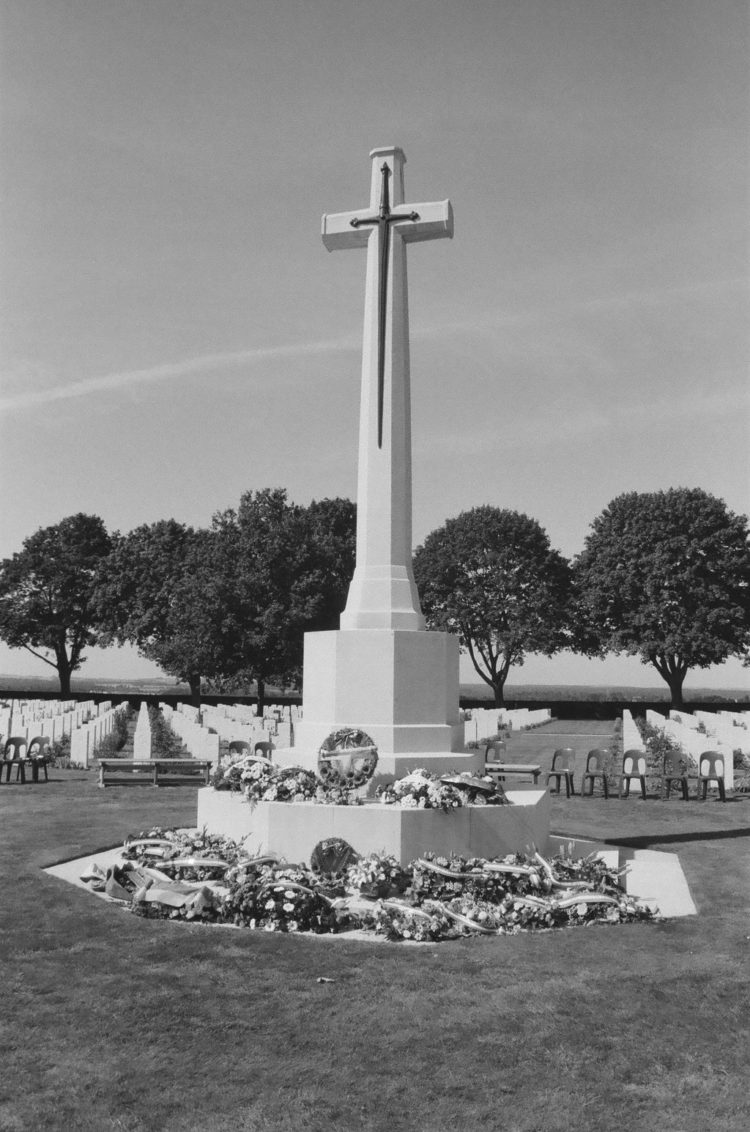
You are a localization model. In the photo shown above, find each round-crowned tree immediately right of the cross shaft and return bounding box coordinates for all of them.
[414,506,570,708]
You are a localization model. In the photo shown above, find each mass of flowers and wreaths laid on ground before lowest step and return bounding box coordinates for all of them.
[83,829,655,942]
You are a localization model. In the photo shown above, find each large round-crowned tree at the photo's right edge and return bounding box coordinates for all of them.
[574,488,750,709]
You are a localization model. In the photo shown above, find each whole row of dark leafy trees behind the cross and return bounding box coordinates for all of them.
[0,488,750,706]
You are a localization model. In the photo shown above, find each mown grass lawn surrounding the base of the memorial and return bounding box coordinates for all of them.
[0,770,750,1132]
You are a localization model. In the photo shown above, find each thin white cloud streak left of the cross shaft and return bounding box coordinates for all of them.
[0,336,361,421]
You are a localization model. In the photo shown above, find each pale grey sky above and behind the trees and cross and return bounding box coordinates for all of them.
[0,0,750,686]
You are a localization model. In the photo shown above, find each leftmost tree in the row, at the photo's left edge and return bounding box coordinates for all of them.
[0,513,111,696]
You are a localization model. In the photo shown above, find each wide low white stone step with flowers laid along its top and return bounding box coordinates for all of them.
[197,787,550,865]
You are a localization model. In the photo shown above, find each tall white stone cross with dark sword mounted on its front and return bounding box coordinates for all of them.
[322,146,454,629]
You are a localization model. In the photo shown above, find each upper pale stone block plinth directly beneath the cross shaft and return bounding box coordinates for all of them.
[294,629,463,766]
